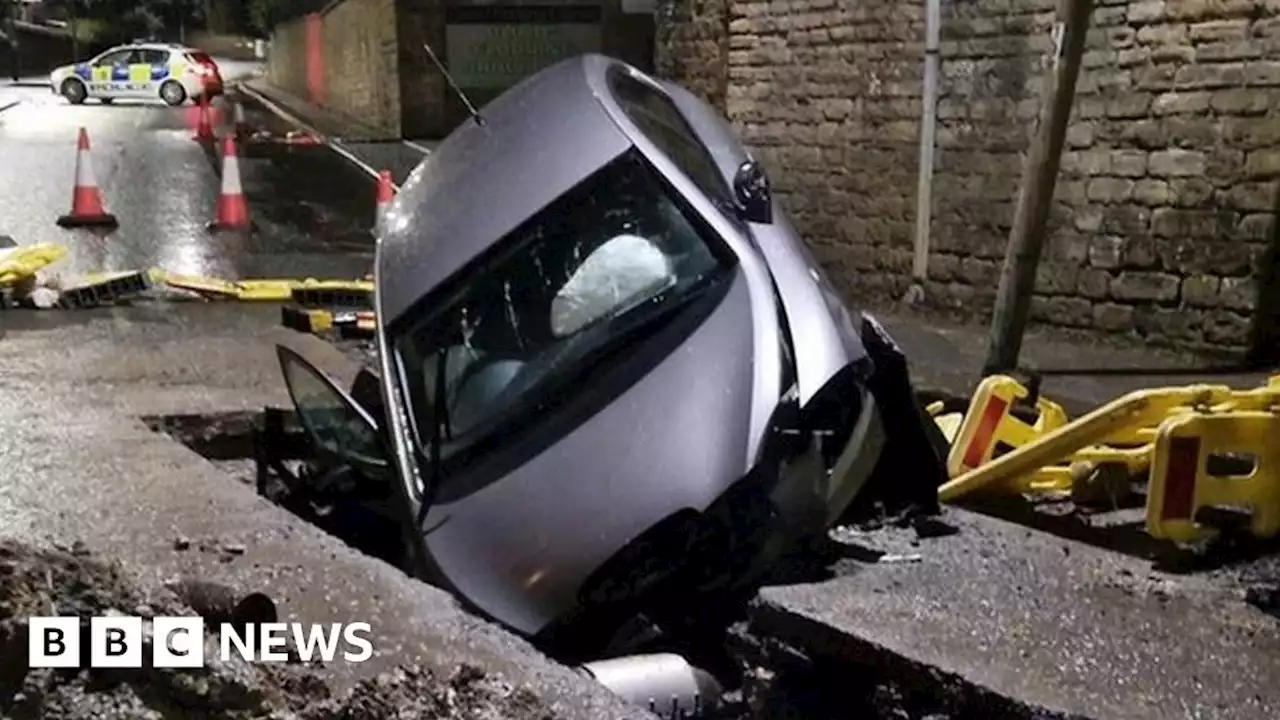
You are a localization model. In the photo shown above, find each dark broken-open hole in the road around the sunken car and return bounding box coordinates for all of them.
[142,410,1054,720]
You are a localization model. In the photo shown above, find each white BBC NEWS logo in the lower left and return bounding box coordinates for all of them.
[27,615,374,667]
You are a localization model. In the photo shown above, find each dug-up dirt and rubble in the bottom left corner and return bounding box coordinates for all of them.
[0,541,557,720]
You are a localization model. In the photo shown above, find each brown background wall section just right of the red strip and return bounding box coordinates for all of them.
[323,0,401,137]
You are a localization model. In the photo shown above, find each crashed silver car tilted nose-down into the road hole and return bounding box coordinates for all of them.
[282,55,933,657]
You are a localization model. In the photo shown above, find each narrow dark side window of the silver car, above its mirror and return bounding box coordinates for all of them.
[609,68,735,218]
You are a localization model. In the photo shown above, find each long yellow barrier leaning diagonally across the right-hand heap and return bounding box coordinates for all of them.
[938,383,1256,502]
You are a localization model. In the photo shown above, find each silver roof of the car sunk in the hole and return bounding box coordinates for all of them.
[378,54,632,320]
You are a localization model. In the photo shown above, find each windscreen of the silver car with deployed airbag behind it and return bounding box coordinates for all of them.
[392,150,735,468]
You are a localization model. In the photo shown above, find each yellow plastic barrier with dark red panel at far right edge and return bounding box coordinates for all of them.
[1147,407,1280,542]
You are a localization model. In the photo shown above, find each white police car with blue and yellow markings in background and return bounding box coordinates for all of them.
[49,42,215,105]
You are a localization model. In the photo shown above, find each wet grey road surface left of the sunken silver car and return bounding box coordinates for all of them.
[0,60,649,720]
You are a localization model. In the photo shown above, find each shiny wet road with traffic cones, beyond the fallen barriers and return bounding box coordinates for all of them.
[0,61,374,278]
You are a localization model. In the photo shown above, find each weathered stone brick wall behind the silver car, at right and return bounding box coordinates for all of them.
[658,0,1280,345]
